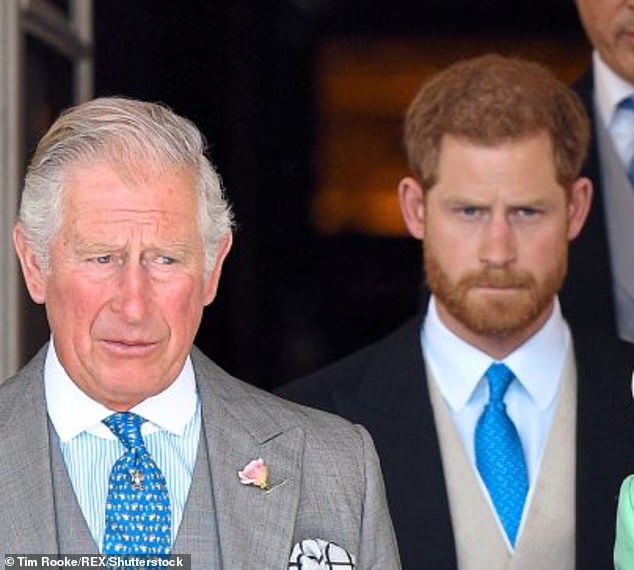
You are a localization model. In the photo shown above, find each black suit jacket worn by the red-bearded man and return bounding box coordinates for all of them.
[280,317,634,570]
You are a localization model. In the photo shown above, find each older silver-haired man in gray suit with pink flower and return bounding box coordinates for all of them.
[0,98,400,570]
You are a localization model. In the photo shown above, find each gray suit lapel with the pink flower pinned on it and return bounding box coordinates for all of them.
[193,352,304,569]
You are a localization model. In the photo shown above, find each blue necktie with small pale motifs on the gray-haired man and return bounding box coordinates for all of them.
[103,412,172,555]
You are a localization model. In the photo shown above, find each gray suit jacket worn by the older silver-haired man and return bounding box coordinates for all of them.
[0,349,400,570]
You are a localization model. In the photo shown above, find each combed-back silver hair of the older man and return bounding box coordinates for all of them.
[18,97,233,274]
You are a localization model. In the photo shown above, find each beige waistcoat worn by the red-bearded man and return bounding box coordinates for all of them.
[427,350,577,570]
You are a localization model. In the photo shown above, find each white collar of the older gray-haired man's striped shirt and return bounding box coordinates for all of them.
[44,338,198,442]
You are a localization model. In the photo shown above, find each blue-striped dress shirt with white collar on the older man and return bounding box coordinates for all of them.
[44,341,201,550]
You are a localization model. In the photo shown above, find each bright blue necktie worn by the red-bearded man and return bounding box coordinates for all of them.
[475,364,528,546]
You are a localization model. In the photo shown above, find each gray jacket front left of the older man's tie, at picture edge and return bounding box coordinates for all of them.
[0,347,58,554]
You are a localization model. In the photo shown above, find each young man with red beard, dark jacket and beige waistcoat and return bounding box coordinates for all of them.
[282,55,634,570]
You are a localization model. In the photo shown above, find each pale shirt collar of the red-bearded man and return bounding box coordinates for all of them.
[421,296,571,411]
